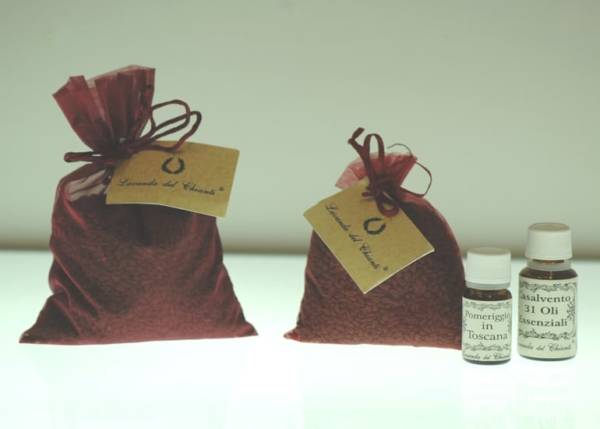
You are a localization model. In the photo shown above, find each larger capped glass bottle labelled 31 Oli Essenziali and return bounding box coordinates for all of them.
[518,223,577,360]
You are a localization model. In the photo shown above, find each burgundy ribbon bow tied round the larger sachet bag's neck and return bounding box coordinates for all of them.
[65,100,202,167]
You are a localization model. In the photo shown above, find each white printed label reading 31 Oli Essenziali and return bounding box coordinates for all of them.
[519,277,577,359]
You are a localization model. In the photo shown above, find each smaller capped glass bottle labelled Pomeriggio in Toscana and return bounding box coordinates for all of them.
[462,247,512,364]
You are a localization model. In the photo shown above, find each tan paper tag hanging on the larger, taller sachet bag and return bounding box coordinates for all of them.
[106,142,239,217]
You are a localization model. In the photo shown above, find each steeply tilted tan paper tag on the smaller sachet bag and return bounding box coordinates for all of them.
[304,179,434,293]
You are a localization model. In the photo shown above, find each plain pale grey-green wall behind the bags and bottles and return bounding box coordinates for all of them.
[0,0,600,257]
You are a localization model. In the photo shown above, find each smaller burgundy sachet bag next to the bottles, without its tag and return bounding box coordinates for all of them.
[285,128,465,349]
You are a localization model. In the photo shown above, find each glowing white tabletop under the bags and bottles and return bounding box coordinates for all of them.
[0,252,600,429]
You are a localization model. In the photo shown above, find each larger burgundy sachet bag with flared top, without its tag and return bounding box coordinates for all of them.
[21,66,256,344]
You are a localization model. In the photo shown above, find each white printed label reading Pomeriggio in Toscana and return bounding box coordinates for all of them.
[462,298,512,362]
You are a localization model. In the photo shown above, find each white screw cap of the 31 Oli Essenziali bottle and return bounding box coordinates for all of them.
[525,223,573,261]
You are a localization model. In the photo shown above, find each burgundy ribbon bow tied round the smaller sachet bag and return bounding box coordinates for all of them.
[348,127,433,217]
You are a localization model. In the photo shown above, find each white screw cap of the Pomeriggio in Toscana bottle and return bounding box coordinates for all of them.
[466,247,510,289]
